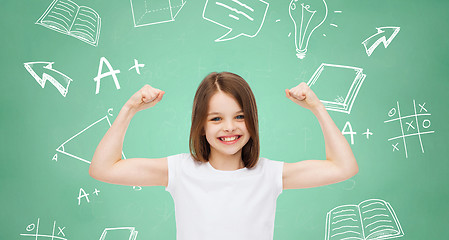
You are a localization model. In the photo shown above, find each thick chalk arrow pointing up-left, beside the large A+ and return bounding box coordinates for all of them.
[23,62,72,97]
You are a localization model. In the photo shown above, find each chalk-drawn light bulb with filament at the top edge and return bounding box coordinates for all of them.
[288,0,328,59]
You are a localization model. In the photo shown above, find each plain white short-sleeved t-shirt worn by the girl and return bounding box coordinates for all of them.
[166,153,284,240]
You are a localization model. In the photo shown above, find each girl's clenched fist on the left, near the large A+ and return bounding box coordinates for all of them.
[126,84,165,112]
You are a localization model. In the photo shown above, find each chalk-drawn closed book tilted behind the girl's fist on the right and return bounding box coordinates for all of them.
[307,63,366,114]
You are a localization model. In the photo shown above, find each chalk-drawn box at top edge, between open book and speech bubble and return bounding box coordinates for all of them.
[131,0,186,27]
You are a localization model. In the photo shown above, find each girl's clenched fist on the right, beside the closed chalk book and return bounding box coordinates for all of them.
[285,82,323,110]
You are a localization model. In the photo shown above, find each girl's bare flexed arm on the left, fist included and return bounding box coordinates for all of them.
[89,85,168,186]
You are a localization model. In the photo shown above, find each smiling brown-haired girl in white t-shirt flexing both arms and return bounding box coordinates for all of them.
[89,72,358,240]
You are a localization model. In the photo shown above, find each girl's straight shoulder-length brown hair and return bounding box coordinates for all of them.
[189,72,260,168]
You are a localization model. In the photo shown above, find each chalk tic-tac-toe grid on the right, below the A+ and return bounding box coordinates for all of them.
[384,100,435,158]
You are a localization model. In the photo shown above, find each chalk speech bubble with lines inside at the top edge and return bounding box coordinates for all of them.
[203,0,269,42]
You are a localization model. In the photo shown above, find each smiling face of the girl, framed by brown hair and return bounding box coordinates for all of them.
[204,91,250,157]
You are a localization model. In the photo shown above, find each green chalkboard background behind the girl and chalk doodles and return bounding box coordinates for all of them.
[0,0,449,240]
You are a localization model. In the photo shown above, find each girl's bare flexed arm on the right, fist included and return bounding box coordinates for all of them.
[283,83,358,189]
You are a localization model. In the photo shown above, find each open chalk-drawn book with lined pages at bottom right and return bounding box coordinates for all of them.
[325,199,404,240]
